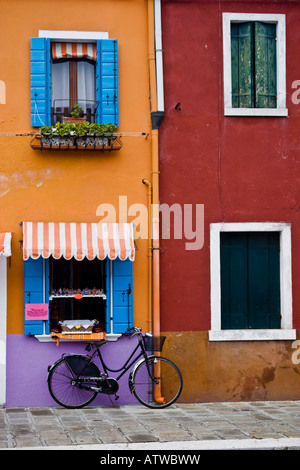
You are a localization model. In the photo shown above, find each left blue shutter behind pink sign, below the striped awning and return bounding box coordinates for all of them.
[24,258,50,335]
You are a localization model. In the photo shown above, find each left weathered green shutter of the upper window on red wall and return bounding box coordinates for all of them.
[231,22,254,108]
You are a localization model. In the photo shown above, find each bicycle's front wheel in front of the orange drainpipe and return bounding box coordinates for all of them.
[130,356,183,408]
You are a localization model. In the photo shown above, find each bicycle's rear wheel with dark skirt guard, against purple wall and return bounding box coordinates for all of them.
[48,354,100,408]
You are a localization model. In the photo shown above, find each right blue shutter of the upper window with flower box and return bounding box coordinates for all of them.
[96,39,119,126]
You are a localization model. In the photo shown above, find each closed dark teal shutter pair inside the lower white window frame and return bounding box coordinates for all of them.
[220,232,280,329]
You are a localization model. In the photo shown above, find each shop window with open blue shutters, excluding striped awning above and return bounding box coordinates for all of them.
[24,257,133,335]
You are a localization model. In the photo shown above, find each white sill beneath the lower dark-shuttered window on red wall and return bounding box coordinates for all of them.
[208,329,296,341]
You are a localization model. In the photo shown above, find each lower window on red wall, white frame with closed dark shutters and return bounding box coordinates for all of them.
[209,223,295,341]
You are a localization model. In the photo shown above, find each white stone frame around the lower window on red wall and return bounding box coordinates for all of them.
[209,222,296,341]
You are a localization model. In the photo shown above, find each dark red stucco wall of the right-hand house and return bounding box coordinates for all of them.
[160,0,300,331]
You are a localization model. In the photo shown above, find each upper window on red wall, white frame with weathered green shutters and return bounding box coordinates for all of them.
[223,13,287,116]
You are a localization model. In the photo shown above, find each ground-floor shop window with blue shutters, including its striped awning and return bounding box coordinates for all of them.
[23,222,135,336]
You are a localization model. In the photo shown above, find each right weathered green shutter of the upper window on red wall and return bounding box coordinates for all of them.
[254,22,277,108]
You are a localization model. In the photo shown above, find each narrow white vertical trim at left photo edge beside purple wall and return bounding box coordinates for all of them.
[0,256,7,406]
